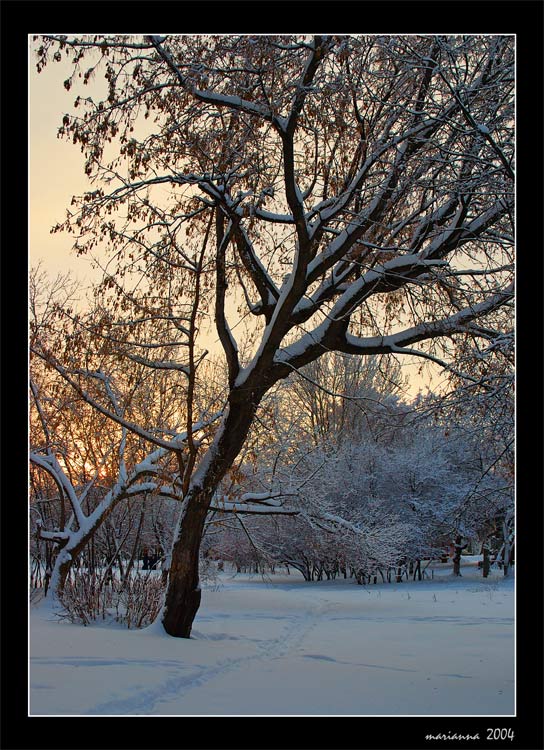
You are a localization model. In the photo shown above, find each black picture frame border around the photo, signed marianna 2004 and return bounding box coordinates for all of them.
[0,0,544,750]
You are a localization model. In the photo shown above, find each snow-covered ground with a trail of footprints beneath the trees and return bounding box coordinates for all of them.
[29,567,515,716]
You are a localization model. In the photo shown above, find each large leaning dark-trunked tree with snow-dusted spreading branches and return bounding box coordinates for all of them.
[36,36,514,637]
